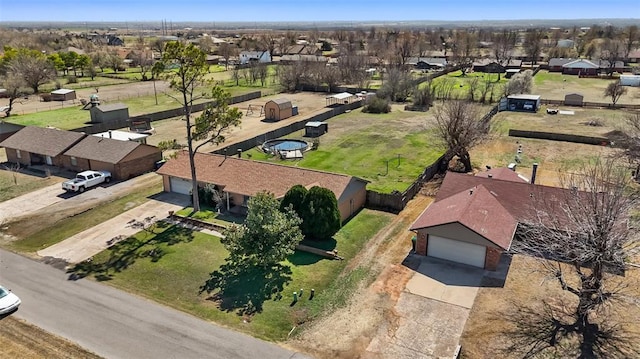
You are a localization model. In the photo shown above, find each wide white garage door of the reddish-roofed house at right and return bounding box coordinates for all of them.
[427,235,487,268]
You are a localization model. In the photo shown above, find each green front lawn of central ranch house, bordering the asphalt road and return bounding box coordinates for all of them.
[67,209,393,341]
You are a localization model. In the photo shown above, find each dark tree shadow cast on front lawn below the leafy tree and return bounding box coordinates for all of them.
[199,262,292,316]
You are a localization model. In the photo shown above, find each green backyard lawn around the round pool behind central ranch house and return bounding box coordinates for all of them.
[246,109,443,193]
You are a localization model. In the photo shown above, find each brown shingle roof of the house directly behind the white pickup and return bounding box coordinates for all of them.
[64,136,151,163]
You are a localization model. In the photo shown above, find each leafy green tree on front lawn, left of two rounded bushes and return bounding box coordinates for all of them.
[221,192,303,268]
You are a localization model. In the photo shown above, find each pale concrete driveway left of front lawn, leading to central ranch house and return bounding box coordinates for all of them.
[38,193,190,263]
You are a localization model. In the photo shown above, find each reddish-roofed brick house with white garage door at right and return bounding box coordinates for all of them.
[410,169,570,270]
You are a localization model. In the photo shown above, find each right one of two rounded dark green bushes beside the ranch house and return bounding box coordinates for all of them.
[302,186,341,239]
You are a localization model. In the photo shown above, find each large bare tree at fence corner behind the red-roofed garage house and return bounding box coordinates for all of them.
[434,100,488,172]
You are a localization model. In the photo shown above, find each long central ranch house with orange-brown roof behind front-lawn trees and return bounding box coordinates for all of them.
[157,152,367,222]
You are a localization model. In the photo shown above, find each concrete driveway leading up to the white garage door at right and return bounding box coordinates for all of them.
[363,254,485,359]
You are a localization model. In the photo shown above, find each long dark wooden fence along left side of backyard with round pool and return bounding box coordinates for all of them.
[213,101,363,155]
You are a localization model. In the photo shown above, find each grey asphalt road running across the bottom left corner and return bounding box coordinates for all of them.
[0,250,308,359]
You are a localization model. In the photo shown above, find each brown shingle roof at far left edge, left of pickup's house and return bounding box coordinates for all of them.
[0,126,86,157]
